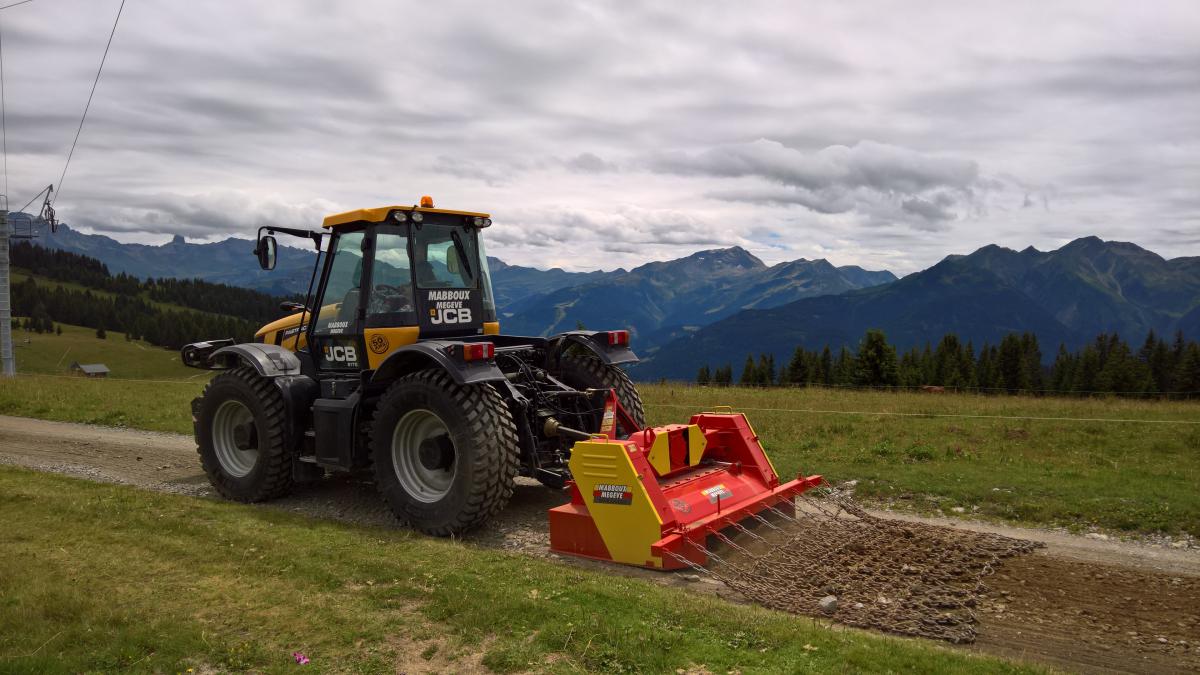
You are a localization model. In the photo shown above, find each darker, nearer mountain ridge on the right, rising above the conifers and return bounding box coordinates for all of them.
[636,237,1200,378]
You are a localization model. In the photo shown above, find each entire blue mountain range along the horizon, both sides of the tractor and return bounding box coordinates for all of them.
[23,219,1200,378]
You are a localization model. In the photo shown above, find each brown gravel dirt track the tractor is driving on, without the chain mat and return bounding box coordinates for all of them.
[0,416,1200,673]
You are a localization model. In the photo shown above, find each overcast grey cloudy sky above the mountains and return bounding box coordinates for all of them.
[0,0,1200,274]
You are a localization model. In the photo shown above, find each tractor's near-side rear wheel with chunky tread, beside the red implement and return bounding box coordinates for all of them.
[371,370,520,537]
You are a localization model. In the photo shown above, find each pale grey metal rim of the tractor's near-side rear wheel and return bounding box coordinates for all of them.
[391,410,458,503]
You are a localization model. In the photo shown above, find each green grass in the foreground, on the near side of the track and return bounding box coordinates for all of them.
[0,467,1032,674]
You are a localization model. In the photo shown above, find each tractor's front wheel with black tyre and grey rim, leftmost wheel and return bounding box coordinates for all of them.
[197,366,292,502]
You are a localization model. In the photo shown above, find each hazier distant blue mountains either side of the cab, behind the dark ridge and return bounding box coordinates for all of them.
[25,225,895,351]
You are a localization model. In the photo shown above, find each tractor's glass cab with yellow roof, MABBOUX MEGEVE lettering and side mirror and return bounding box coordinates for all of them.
[257,197,499,371]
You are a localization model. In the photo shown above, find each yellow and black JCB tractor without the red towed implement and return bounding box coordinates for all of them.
[181,197,643,536]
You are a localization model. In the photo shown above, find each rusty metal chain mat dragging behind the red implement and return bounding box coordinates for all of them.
[670,488,1042,644]
